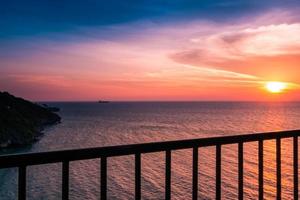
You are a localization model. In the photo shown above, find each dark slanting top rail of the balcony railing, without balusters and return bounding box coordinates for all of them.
[0,130,300,168]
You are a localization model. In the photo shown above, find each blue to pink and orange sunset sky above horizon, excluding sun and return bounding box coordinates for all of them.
[0,0,300,101]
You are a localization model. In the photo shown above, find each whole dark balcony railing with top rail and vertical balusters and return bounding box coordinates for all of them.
[0,130,300,200]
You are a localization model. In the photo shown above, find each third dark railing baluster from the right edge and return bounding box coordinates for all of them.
[258,140,264,200]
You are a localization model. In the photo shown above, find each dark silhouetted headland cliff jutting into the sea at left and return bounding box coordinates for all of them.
[0,92,61,148]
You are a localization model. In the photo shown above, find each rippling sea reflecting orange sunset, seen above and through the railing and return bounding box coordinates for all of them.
[0,102,300,200]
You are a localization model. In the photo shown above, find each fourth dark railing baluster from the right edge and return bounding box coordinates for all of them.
[238,142,244,200]
